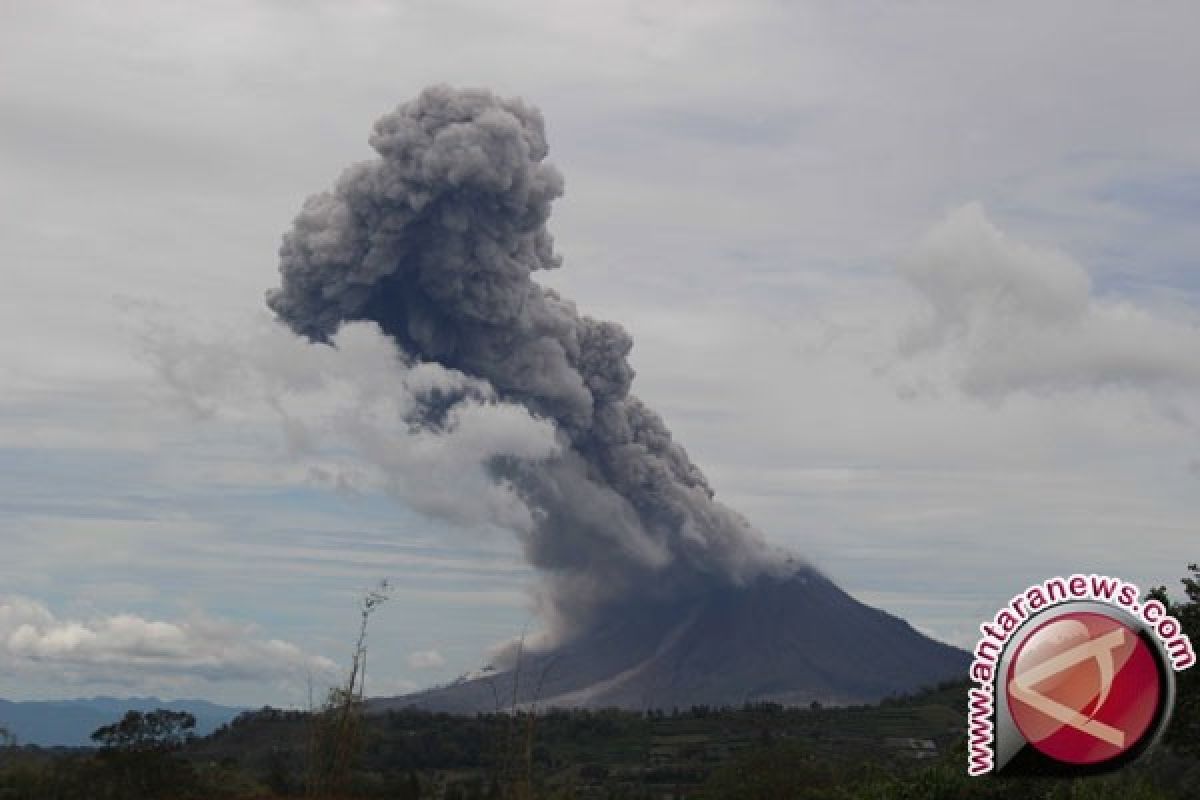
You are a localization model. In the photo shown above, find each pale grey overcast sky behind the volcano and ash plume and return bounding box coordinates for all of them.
[0,0,1200,705]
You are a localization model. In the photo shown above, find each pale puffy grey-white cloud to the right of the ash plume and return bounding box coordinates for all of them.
[901,204,1200,397]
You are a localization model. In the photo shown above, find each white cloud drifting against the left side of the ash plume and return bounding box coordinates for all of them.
[144,318,558,531]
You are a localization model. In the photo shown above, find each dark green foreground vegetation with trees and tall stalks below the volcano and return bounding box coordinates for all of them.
[0,565,1200,800]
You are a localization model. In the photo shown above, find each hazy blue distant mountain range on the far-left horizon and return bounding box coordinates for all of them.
[0,697,245,747]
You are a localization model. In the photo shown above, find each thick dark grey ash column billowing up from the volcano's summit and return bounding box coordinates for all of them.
[268,86,780,633]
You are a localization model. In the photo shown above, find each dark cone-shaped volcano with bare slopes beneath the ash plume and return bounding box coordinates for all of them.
[379,569,970,714]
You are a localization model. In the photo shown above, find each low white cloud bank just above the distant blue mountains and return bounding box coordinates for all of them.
[0,596,335,682]
